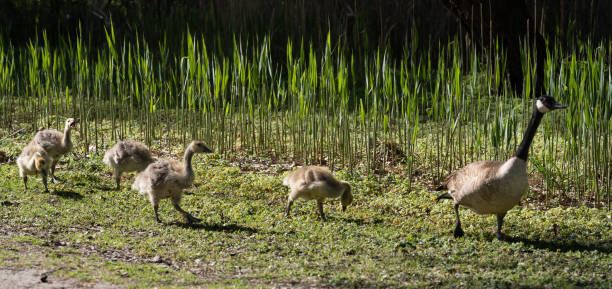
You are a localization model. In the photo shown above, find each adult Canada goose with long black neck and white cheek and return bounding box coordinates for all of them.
[436,95,565,239]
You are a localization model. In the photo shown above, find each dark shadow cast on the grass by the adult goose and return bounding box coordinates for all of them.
[504,236,612,254]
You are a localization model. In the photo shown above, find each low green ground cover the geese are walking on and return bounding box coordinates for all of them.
[0,127,612,288]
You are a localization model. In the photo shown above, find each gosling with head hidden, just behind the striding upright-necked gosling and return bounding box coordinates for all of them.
[102,141,154,190]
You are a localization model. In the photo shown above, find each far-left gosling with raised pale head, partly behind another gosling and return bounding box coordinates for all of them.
[33,118,79,182]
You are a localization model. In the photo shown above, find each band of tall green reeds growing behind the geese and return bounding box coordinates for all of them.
[0,27,612,208]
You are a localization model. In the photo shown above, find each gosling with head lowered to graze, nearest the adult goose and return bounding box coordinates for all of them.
[283,166,353,220]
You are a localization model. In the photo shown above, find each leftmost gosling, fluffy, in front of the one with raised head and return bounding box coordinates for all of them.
[17,142,51,193]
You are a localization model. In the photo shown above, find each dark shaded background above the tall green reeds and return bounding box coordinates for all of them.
[0,0,612,95]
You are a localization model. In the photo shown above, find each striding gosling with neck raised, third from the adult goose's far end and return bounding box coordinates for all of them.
[132,140,212,224]
